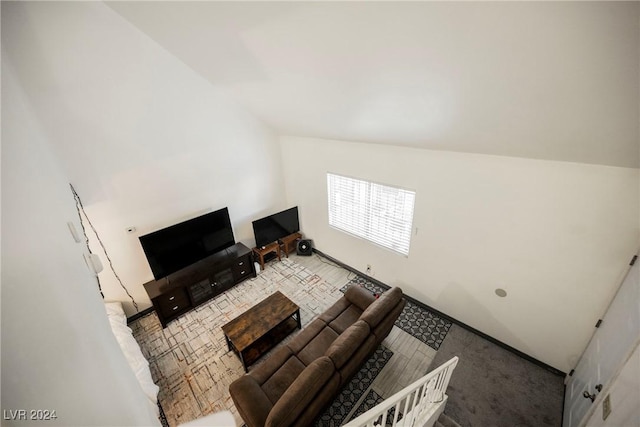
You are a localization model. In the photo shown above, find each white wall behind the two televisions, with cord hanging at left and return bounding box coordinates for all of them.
[3,2,286,314]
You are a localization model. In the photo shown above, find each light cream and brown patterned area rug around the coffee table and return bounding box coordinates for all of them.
[129,259,350,427]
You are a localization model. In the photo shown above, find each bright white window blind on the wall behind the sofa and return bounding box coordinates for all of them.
[327,173,416,255]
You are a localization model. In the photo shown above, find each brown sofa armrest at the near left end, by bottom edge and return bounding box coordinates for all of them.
[229,375,273,427]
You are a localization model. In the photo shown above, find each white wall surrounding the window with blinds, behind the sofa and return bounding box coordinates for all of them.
[281,137,640,372]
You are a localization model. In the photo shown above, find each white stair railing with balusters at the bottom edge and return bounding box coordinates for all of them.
[343,357,458,427]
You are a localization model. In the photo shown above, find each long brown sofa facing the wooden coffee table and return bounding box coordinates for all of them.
[229,286,406,427]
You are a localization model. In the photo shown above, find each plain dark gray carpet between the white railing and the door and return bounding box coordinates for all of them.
[430,325,564,427]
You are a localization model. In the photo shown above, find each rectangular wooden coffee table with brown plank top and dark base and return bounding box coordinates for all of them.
[222,291,302,372]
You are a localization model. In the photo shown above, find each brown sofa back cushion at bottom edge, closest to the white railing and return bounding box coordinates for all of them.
[265,356,335,427]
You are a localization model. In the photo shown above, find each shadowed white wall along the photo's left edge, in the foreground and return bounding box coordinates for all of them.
[1,41,158,426]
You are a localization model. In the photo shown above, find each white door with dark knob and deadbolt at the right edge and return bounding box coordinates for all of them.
[562,261,640,427]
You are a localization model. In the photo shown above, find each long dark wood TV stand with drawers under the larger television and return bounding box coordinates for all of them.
[144,243,256,328]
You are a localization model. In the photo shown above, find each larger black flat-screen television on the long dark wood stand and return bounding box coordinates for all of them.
[140,208,235,280]
